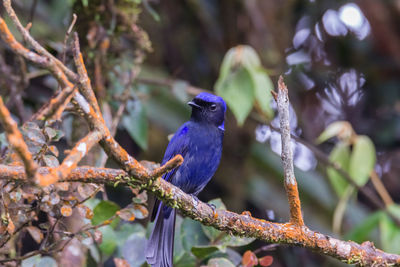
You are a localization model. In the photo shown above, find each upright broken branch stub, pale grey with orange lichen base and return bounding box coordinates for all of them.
[275,76,304,226]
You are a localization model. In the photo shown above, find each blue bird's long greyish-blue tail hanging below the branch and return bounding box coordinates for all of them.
[146,203,176,267]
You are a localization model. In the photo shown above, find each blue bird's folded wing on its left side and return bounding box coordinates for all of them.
[151,123,189,221]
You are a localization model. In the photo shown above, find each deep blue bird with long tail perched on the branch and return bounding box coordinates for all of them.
[146,93,226,267]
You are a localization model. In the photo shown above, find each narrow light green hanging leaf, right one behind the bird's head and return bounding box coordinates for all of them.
[250,68,274,118]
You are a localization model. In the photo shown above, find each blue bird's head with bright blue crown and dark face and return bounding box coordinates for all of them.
[188,93,226,131]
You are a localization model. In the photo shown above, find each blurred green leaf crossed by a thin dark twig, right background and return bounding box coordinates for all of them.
[327,142,350,197]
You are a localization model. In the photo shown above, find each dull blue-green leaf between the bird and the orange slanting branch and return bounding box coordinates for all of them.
[122,101,149,150]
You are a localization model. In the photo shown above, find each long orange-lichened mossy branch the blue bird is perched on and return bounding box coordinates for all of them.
[0,165,400,266]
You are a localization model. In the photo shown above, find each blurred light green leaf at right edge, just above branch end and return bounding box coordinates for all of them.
[379,214,400,254]
